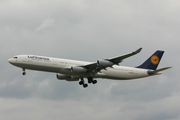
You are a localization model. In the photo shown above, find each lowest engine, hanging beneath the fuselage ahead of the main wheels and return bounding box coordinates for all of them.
[56,73,79,81]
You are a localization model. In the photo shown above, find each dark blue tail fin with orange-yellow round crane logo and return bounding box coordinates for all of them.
[137,50,164,70]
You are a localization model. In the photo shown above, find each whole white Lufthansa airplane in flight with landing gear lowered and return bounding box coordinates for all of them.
[8,48,171,88]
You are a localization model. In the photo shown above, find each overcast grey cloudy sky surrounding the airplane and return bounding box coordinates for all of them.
[0,0,180,120]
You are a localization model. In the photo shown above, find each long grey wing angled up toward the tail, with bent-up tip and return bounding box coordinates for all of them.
[81,48,142,75]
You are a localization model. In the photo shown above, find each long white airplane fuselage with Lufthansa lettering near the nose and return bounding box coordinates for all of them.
[8,55,152,80]
